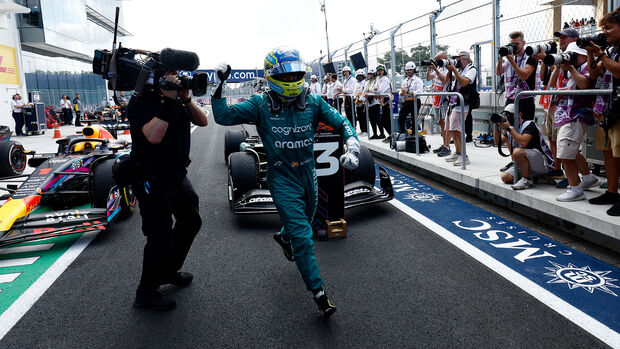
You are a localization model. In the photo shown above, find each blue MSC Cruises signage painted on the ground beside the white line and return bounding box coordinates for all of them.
[387,169,620,333]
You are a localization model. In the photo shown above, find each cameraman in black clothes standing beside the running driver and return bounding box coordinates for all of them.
[128,71,208,310]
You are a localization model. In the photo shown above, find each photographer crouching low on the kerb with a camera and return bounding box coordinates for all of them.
[498,103,552,190]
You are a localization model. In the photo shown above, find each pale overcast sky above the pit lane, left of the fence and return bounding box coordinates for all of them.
[121,0,454,69]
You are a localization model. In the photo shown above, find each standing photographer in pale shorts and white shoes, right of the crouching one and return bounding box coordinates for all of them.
[549,42,599,201]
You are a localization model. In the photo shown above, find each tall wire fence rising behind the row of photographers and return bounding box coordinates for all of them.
[311,0,608,89]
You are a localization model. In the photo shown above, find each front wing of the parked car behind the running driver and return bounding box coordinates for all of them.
[232,166,394,214]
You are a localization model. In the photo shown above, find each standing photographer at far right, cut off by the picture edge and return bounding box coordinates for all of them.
[586,9,620,216]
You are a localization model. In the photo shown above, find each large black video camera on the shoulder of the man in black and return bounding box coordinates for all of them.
[93,45,208,96]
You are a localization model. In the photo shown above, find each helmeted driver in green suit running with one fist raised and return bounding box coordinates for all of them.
[211,47,360,318]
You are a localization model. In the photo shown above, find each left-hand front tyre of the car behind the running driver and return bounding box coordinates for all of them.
[228,152,259,204]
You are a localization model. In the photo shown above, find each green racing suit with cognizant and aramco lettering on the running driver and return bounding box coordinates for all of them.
[211,93,357,290]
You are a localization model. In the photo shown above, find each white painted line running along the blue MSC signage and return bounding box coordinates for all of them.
[388,199,620,348]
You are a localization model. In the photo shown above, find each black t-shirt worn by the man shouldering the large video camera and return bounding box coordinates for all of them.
[127,93,191,177]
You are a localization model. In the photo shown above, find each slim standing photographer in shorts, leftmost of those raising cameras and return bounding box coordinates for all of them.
[426,51,451,157]
